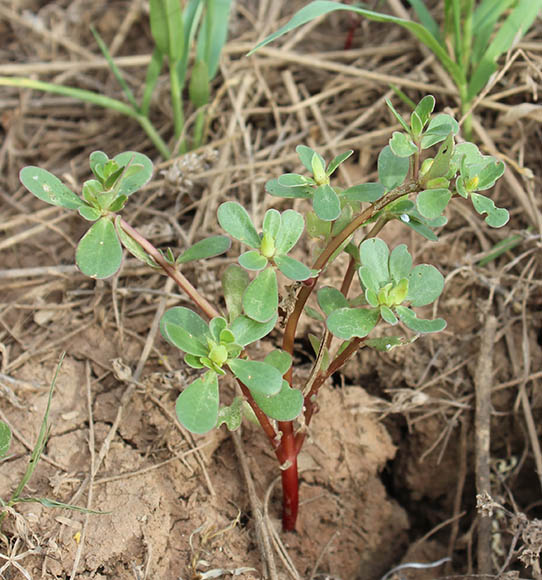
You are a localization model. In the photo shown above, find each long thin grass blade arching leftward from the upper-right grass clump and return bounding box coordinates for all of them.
[248,0,466,86]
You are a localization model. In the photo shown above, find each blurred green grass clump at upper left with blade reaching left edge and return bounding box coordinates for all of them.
[0,0,231,159]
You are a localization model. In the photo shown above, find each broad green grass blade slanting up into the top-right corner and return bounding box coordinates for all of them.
[468,0,542,100]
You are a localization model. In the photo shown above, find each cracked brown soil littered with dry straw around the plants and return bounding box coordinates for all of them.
[0,0,542,580]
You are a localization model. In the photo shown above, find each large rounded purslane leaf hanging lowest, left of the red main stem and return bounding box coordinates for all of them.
[175,372,219,434]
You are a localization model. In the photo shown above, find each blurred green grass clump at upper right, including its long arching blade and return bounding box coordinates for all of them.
[251,0,542,139]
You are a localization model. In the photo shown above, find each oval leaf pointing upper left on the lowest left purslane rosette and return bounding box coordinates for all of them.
[160,306,211,356]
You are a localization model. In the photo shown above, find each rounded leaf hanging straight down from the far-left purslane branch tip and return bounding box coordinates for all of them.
[75,218,122,279]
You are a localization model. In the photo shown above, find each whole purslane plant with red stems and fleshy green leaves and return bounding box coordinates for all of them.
[21,96,508,530]
